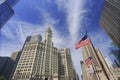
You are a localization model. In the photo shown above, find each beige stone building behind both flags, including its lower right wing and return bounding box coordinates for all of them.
[80,43,120,80]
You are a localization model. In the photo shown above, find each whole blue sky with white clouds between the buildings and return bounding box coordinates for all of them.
[0,0,114,79]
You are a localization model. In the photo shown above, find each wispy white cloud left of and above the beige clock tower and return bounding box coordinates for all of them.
[0,11,60,56]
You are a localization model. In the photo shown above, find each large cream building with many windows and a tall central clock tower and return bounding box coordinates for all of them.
[12,28,76,80]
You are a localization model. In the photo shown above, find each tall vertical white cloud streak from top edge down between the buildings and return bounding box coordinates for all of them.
[56,0,86,75]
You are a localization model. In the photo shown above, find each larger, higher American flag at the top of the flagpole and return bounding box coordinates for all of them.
[75,34,90,49]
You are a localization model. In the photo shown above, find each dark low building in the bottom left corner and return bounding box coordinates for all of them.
[0,57,15,80]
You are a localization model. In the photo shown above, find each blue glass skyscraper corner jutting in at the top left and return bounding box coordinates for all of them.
[0,0,19,29]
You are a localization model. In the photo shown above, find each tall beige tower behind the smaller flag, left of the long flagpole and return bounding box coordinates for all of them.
[82,43,107,80]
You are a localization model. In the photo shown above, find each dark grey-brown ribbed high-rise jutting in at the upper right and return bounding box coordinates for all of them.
[100,0,120,48]
